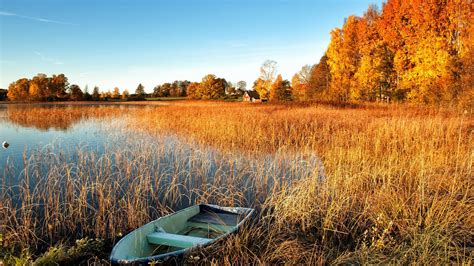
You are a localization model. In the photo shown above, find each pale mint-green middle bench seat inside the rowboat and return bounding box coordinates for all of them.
[146,232,212,248]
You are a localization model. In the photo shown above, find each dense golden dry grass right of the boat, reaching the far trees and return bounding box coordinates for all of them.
[131,103,474,264]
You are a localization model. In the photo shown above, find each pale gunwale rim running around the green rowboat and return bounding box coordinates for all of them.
[110,204,255,264]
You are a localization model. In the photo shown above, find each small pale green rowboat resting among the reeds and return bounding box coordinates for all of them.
[110,204,254,264]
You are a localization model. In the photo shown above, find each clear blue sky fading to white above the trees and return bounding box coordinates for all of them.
[0,0,382,92]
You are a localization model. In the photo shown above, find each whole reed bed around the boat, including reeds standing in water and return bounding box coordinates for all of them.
[0,102,474,265]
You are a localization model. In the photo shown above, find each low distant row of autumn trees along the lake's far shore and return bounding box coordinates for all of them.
[0,74,252,101]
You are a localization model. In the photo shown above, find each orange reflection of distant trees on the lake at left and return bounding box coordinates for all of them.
[6,105,130,130]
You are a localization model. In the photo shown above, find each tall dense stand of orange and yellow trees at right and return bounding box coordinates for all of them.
[298,0,474,105]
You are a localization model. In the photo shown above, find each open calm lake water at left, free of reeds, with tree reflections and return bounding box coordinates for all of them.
[0,104,131,183]
